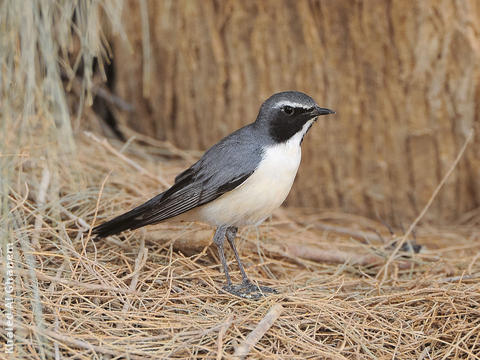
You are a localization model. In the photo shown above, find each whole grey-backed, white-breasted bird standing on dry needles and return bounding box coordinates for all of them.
[92,91,335,299]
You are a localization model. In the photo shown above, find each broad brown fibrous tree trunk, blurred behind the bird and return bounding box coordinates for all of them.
[107,1,480,225]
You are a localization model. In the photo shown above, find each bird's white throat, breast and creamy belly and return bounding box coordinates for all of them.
[191,120,313,226]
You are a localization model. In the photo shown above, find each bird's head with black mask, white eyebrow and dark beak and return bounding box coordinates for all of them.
[255,91,335,143]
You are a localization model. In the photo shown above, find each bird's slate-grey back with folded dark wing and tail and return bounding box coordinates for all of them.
[92,127,262,237]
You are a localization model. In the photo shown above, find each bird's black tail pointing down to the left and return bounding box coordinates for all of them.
[92,194,163,238]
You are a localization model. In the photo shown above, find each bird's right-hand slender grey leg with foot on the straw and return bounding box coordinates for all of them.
[224,226,277,299]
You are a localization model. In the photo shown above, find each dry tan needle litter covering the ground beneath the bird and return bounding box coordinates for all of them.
[2,134,480,359]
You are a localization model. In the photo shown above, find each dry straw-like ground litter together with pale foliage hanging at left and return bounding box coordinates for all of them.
[0,1,480,359]
